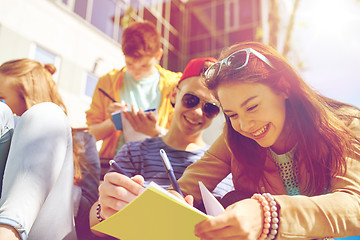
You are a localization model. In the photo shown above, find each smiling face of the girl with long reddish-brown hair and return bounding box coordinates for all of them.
[217,83,287,151]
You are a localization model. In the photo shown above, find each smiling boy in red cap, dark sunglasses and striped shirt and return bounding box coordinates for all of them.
[90,58,233,232]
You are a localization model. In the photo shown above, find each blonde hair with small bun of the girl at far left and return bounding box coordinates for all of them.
[0,58,87,185]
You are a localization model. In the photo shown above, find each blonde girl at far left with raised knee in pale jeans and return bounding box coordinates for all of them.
[0,59,100,239]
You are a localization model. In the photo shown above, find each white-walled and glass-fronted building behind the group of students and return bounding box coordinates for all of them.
[0,0,261,142]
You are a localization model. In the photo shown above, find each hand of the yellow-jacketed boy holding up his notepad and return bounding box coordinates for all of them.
[124,106,161,137]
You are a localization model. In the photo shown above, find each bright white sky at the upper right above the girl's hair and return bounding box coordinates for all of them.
[292,0,360,107]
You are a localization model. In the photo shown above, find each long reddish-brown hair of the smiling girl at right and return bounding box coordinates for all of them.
[206,42,360,195]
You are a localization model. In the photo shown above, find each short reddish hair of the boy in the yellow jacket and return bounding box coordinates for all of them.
[121,21,161,58]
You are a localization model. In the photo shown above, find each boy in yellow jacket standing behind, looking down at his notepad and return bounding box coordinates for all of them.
[86,21,181,162]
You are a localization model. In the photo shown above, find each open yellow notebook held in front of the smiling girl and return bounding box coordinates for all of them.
[92,182,218,240]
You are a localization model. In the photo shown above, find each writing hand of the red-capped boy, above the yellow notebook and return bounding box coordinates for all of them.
[99,172,144,218]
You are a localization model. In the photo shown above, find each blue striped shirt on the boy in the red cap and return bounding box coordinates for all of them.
[109,137,234,197]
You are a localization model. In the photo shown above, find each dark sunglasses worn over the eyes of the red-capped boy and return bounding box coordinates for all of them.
[181,93,220,118]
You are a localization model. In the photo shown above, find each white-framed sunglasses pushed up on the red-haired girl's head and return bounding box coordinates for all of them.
[205,48,275,80]
